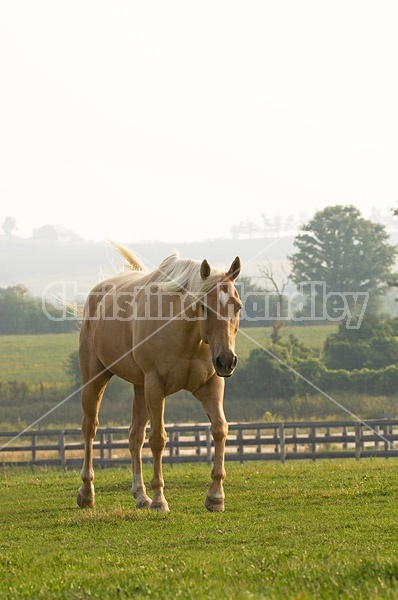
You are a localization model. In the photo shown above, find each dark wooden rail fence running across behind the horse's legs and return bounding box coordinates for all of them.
[0,419,398,469]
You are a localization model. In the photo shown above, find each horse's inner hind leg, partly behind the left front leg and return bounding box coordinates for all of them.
[129,385,151,508]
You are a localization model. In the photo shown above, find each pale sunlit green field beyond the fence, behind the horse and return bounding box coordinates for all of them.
[0,326,336,385]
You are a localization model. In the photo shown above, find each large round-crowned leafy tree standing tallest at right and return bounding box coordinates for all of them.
[289,206,397,310]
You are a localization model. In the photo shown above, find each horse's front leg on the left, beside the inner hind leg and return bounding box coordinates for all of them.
[145,375,169,512]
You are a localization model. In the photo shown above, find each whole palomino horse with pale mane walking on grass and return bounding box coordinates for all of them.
[77,245,242,511]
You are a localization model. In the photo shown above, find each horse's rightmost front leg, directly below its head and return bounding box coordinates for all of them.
[194,375,228,512]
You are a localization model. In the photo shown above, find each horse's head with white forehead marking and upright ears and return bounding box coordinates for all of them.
[200,257,242,377]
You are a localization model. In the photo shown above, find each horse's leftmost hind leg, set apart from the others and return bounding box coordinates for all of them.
[77,371,111,508]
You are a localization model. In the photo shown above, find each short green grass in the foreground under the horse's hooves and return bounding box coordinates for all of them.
[0,459,398,600]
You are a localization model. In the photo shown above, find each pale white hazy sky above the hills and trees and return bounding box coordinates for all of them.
[0,0,398,243]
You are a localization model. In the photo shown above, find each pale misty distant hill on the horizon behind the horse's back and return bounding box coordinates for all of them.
[0,232,294,296]
